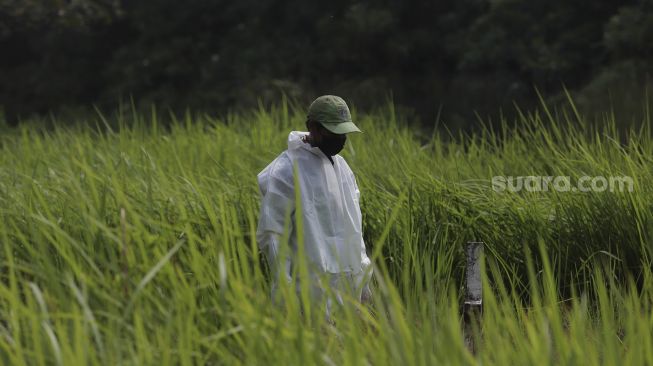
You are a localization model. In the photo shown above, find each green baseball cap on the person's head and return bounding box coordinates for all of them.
[308,95,361,135]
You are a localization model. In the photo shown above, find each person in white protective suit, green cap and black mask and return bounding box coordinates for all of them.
[256,95,372,318]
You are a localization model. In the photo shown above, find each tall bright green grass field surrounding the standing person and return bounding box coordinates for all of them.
[0,99,653,365]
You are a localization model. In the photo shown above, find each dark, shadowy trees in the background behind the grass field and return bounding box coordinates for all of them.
[0,0,653,128]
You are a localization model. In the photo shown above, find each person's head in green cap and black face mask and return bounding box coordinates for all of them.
[306,95,361,156]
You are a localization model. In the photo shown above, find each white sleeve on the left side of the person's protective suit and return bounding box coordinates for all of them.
[256,154,295,284]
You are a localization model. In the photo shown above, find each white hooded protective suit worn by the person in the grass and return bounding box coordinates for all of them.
[256,131,371,308]
